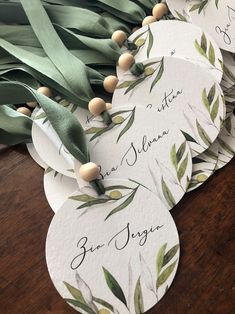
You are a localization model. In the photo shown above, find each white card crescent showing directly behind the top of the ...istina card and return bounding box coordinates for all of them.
[121,21,223,82]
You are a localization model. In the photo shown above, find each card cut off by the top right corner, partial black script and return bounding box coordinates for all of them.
[188,0,235,52]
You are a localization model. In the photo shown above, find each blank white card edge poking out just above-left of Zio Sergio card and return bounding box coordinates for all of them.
[43,167,78,213]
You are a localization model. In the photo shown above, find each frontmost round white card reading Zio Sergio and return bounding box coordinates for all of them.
[46,180,179,314]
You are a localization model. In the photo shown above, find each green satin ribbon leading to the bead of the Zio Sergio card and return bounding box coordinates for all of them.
[0,82,104,194]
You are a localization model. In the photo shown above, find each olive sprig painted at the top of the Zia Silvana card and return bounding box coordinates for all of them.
[85,107,136,143]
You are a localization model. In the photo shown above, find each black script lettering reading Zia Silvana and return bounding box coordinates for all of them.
[99,130,170,179]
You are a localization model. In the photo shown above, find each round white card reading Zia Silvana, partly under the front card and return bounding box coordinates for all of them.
[81,106,192,209]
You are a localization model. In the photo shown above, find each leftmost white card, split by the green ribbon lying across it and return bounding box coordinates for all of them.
[32,103,91,178]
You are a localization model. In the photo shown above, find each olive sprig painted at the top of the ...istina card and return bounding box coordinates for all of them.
[116,57,164,95]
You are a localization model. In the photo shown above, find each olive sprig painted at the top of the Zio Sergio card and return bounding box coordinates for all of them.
[69,179,148,220]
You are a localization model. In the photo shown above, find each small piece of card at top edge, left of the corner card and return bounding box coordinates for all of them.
[166,0,191,22]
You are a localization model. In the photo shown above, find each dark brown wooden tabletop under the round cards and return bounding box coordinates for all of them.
[0,146,235,314]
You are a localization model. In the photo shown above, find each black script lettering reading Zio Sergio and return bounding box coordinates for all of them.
[70,222,164,270]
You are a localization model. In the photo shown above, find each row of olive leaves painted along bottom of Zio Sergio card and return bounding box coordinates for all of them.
[63,243,179,314]
